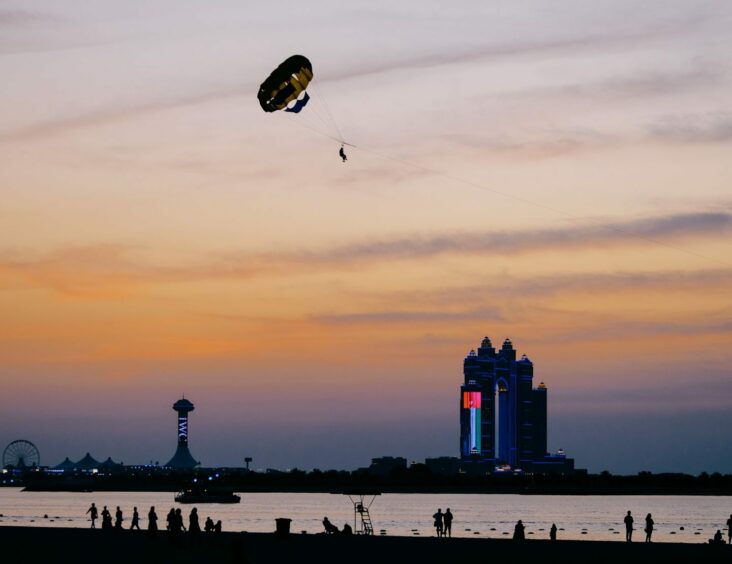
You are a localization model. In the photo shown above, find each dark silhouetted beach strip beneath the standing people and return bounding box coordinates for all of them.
[0,526,732,564]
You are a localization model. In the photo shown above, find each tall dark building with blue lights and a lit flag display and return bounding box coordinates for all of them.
[460,337,574,472]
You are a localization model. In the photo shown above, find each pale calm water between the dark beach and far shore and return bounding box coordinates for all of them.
[0,488,732,543]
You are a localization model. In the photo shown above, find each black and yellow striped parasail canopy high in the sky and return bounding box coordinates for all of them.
[257,55,313,113]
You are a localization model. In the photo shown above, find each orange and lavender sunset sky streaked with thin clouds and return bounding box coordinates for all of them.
[0,0,732,473]
